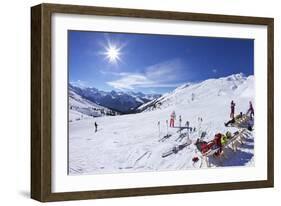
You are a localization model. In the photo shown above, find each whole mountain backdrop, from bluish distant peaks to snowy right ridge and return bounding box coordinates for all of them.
[69,74,250,116]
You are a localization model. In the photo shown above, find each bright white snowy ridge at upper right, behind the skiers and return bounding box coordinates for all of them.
[138,74,254,111]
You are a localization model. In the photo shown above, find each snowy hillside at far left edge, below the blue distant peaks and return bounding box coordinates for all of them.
[68,87,118,121]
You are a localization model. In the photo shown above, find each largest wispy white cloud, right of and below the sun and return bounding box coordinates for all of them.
[107,59,187,90]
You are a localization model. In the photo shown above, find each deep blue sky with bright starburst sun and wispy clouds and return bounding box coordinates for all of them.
[68,31,254,94]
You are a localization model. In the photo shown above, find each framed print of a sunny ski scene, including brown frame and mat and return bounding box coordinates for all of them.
[31,4,274,202]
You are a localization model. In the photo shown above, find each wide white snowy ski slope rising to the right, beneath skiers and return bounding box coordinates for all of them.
[69,74,255,175]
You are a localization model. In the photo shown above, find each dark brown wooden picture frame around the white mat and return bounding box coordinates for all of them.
[31,4,274,202]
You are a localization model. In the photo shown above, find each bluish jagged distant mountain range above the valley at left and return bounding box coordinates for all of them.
[69,84,161,114]
